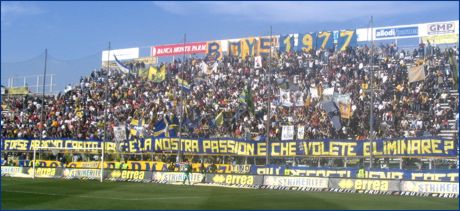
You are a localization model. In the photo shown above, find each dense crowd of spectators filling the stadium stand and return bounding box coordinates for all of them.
[1,42,458,143]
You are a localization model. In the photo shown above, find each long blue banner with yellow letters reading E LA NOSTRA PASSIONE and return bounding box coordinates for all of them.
[1,137,458,158]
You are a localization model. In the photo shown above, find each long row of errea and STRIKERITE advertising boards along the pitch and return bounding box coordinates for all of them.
[1,166,459,198]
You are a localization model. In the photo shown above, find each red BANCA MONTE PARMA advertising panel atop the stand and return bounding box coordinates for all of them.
[150,42,207,57]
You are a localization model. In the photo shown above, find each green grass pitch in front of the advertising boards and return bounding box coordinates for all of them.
[1,177,459,210]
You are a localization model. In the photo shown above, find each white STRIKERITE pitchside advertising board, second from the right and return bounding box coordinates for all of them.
[264,176,328,188]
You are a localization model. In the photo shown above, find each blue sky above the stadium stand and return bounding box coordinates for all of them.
[1,1,459,91]
